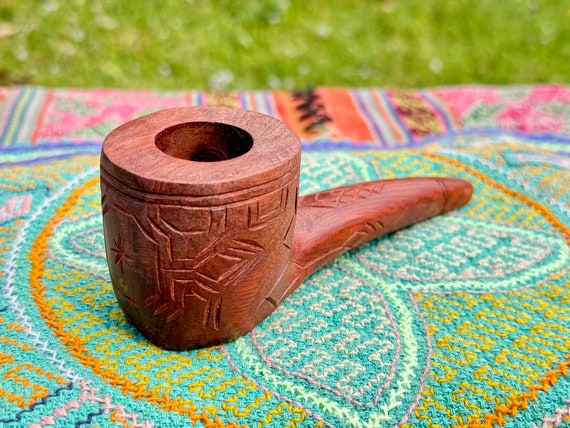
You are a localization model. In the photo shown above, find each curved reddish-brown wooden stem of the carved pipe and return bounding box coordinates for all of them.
[263,178,473,315]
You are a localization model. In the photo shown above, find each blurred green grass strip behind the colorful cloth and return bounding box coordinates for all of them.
[0,0,570,89]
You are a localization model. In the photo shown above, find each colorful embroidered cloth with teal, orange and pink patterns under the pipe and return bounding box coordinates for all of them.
[0,86,570,427]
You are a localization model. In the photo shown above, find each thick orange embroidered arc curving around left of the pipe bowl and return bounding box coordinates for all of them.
[28,177,239,428]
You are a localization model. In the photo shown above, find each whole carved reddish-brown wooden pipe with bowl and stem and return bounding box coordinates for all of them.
[101,107,473,350]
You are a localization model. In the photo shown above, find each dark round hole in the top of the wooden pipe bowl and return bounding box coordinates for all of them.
[154,122,253,162]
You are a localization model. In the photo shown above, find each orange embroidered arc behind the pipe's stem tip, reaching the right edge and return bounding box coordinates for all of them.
[420,152,570,244]
